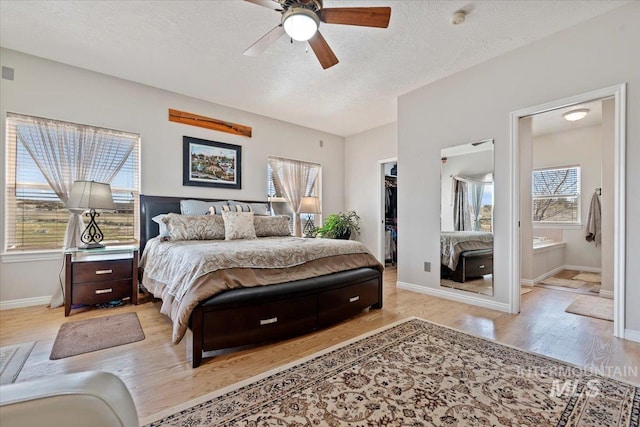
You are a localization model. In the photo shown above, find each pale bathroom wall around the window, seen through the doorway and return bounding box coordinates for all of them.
[523,124,613,270]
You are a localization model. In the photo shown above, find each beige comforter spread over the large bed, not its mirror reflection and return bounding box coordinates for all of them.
[140,237,383,343]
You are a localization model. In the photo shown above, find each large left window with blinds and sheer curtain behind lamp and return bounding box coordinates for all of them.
[4,113,140,251]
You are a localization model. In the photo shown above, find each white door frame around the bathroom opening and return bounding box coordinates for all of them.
[509,83,627,338]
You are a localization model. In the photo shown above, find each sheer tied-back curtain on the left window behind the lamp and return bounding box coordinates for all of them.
[14,116,135,307]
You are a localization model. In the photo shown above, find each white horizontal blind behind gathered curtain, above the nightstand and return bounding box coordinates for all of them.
[4,113,140,251]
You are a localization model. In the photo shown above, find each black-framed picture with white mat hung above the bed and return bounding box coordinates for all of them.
[182,136,242,189]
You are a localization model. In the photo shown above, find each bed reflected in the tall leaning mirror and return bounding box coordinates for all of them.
[440,231,493,283]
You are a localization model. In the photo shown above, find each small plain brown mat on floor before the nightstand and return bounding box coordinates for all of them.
[49,313,144,360]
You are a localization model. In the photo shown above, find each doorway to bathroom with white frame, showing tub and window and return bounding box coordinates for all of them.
[510,85,626,337]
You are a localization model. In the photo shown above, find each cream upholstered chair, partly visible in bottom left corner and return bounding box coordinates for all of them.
[0,372,138,427]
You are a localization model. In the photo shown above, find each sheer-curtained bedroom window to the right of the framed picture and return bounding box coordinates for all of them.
[267,156,322,235]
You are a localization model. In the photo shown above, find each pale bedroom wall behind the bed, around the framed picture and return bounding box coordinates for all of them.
[0,49,345,302]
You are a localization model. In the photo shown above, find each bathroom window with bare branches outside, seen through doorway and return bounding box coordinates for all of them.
[531,166,580,224]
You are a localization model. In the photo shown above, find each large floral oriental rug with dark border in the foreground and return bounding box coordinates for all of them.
[141,318,640,426]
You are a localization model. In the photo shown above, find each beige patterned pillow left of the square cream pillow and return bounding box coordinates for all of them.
[162,213,225,240]
